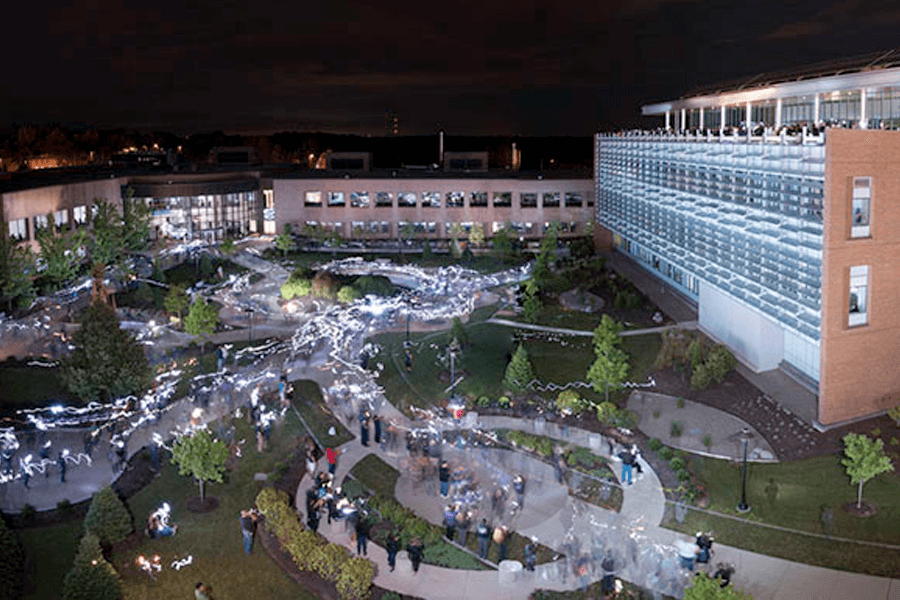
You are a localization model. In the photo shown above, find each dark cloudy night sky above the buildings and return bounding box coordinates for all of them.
[7,0,900,135]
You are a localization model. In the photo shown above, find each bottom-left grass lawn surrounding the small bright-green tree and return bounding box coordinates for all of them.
[23,413,314,600]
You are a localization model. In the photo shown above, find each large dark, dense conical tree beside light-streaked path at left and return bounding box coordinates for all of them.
[61,298,152,402]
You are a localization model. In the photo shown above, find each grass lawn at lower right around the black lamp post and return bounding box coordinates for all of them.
[670,455,900,577]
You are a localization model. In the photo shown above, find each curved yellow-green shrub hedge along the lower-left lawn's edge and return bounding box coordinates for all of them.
[256,488,375,600]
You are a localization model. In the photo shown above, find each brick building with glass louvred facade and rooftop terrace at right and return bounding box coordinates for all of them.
[595,51,900,426]
